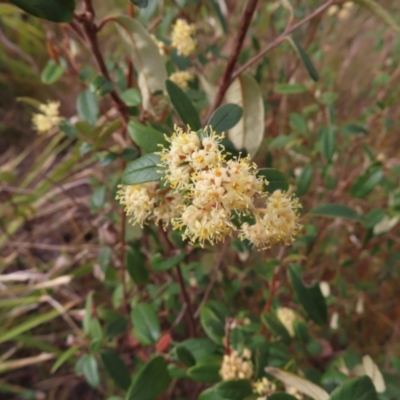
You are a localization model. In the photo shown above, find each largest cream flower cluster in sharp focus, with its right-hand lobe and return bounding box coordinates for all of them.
[160,127,300,248]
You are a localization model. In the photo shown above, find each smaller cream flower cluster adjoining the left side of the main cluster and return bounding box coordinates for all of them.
[116,182,183,226]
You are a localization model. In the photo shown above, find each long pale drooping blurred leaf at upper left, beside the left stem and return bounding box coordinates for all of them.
[115,16,167,113]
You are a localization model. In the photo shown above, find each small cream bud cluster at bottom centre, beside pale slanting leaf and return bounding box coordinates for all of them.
[219,349,253,381]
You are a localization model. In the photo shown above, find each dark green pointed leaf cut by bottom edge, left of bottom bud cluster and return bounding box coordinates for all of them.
[126,356,170,400]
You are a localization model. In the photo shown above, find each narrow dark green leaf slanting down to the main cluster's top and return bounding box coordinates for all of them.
[165,79,201,131]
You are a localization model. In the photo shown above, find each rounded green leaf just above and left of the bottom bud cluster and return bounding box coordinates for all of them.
[200,300,229,343]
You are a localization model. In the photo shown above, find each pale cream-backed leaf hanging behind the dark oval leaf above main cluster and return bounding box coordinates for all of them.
[225,74,265,157]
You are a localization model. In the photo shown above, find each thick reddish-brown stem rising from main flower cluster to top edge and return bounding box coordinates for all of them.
[207,0,258,121]
